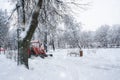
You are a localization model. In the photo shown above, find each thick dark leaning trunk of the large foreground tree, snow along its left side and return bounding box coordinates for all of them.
[19,0,42,69]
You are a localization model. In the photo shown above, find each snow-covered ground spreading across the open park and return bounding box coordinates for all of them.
[0,49,120,80]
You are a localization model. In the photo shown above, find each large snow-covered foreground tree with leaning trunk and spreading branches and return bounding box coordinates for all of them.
[8,0,87,68]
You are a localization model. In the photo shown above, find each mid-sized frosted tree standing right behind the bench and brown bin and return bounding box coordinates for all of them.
[64,15,81,48]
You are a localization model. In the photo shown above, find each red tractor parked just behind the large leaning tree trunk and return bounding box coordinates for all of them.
[28,40,53,58]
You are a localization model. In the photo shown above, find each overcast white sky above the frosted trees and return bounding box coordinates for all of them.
[0,0,120,30]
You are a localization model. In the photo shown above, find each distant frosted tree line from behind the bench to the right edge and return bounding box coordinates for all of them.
[55,25,120,48]
